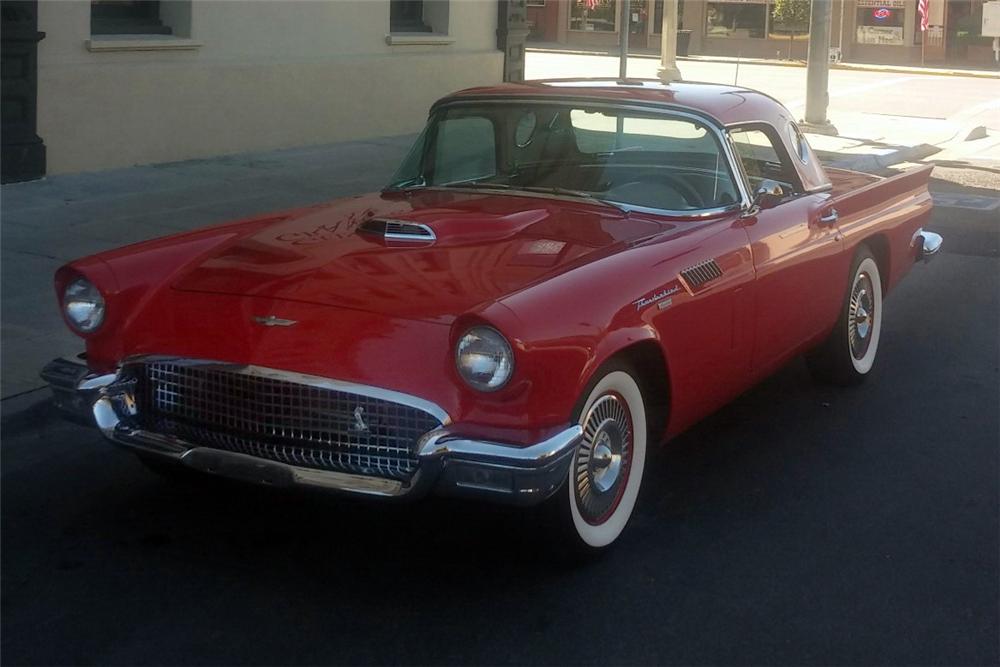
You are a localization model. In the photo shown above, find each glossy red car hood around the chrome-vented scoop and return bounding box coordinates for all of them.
[173,190,670,322]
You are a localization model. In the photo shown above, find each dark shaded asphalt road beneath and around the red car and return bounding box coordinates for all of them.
[0,196,1000,665]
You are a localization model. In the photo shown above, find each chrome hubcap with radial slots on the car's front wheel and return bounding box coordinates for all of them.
[574,394,632,524]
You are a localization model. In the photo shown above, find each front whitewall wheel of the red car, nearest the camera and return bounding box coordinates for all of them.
[548,367,647,554]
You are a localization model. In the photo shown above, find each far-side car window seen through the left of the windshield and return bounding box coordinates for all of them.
[433,116,497,185]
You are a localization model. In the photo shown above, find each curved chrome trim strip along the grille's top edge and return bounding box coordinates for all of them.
[119,355,451,426]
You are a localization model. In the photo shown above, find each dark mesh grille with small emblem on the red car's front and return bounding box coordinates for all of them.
[129,361,441,479]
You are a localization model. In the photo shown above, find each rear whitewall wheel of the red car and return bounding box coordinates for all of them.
[806,246,882,385]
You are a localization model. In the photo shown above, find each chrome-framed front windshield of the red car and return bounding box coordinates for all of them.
[387,102,739,211]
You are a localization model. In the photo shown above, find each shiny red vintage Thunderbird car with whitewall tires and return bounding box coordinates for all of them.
[43,81,941,551]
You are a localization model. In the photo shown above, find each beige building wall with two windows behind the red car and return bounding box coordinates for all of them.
[27,0,503,174]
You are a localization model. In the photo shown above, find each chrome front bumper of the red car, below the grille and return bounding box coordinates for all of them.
[41,359,583,505]
